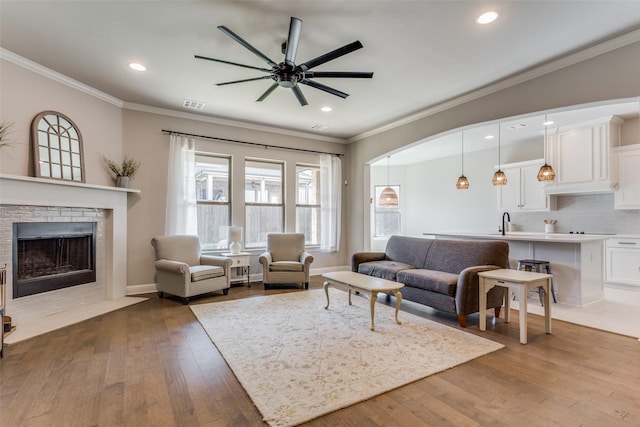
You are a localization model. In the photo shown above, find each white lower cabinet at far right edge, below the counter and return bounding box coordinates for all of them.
[605,237,640,286]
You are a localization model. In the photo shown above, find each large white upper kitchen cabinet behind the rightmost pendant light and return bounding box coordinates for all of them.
[545,116,623,194]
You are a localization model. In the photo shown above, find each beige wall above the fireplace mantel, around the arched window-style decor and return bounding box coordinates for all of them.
[0,59,123,185]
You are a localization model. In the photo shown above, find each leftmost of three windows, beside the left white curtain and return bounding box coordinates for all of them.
[195,153,231,250]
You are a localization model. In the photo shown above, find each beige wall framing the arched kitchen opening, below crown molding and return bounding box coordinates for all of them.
[347,39,640,253]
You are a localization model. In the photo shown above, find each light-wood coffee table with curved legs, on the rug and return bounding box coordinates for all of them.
[322,271,404,331]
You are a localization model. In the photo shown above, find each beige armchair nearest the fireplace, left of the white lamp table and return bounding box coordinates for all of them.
[151,236,232,304]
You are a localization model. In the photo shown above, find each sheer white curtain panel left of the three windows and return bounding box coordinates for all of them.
[165,135,198,235]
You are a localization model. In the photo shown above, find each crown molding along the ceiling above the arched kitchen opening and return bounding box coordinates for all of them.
[347,30,640,143]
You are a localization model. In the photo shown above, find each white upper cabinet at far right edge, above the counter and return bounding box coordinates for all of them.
[613,144,640,209]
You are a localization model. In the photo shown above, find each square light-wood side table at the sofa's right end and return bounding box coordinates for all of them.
[478,269,553,344]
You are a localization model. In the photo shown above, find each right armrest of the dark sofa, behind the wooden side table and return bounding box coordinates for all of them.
[456,265,502,315]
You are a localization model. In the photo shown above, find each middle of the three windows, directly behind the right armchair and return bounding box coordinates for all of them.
[244,160,284,248]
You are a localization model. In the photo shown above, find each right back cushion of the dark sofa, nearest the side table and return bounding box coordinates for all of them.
[423,240,509,274]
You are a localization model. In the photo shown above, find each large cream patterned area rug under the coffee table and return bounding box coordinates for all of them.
[191,288,503,427]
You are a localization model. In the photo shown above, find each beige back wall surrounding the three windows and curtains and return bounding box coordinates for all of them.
[123,110,348,285]
